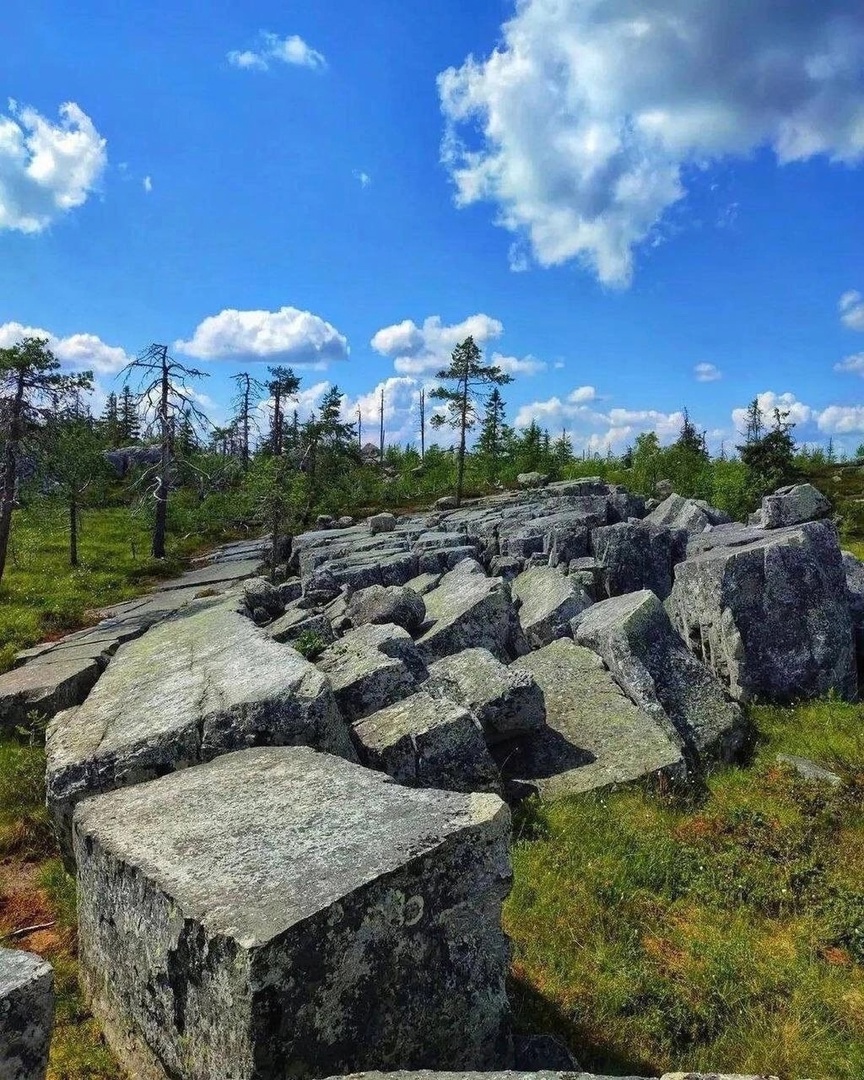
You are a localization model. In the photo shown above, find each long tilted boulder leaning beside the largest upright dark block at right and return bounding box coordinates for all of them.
[573,590,746,761]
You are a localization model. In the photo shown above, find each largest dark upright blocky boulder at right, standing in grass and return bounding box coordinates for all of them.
[669,522,856,702]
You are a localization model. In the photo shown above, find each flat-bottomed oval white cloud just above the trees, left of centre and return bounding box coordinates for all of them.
[174,307,349,369]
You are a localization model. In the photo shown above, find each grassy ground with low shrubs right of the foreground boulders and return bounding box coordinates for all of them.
[505,703,864,1080]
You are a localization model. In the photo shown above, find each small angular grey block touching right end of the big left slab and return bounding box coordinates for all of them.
[316,624,424,723]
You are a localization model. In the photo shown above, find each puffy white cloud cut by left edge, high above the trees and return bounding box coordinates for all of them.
[0,100,108,233]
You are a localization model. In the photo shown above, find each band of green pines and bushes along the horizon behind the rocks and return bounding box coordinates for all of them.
[0,337,842,579]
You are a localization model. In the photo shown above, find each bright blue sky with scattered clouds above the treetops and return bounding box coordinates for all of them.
[0,0,864,451]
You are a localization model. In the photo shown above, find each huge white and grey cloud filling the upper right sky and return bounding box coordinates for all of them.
[438,0,864,285]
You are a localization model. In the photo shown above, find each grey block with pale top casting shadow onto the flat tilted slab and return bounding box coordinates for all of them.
[426,649,546,745]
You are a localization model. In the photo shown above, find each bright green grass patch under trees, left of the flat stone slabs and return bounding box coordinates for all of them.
[0,503,233,672]
